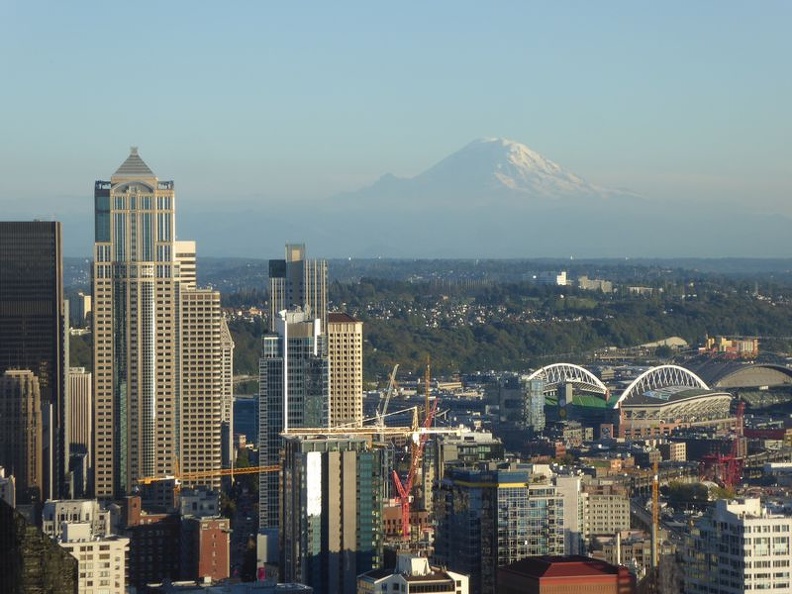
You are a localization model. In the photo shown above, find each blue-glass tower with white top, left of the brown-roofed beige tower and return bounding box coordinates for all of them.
[258,311,328,544]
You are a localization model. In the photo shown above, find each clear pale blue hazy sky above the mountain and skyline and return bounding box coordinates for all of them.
[0,0,792,216]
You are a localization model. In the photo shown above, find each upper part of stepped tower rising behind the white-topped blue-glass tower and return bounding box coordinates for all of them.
[269,243,327,334]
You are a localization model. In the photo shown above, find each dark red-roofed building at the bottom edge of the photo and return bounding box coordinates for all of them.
[497,555,635,594]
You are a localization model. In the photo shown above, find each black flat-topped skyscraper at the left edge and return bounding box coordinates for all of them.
[0,221,68,498]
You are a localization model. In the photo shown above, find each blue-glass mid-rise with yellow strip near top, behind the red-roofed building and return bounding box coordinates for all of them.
[435,463,564,594]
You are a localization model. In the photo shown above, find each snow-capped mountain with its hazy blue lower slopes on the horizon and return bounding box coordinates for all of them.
[164,138,792,258]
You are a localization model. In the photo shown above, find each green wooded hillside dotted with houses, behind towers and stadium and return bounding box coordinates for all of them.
[70,268,792,380]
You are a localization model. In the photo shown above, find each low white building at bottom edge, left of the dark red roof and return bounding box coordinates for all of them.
[357,554,469,594]
